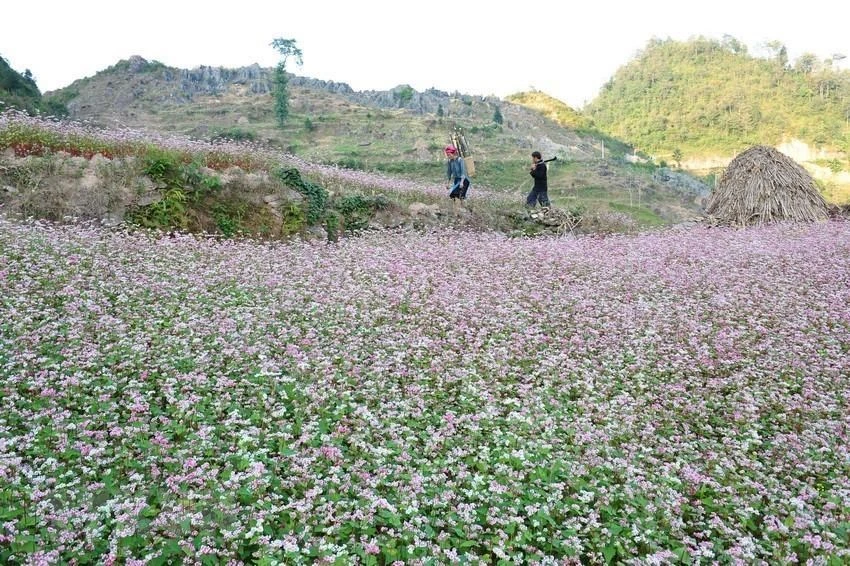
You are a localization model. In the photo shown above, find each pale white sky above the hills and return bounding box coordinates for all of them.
[0,0,850,107]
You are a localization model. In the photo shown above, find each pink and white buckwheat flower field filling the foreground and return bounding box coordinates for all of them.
[0,217,850,565]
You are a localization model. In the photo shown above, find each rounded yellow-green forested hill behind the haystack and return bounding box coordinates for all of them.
[585,36,850,159]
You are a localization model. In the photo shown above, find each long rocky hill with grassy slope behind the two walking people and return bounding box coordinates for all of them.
[43,57,708,223]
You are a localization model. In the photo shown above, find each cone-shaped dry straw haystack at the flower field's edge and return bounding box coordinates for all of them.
[706,145,827,226]
